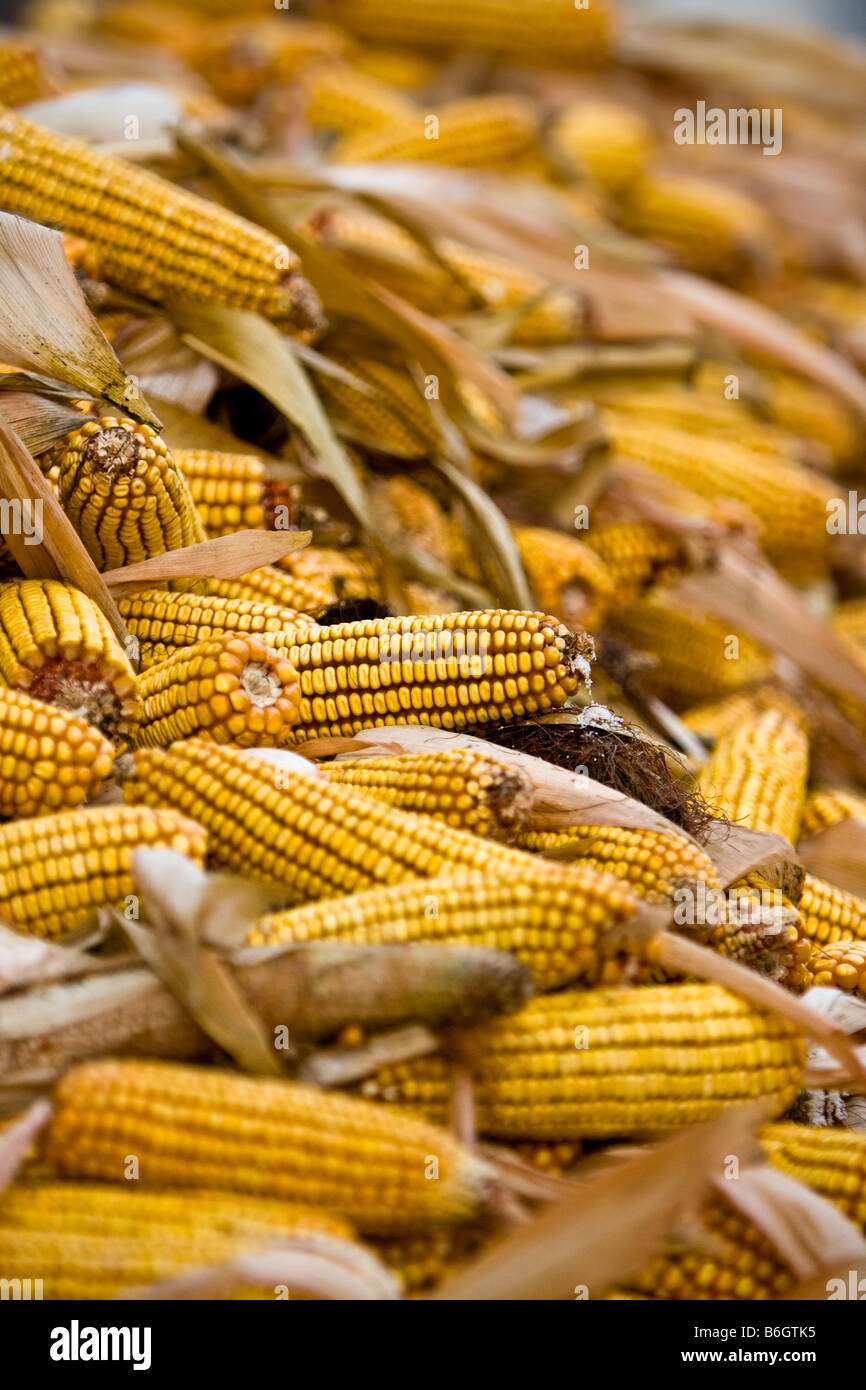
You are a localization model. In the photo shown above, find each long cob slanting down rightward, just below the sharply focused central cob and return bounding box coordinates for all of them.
[125,738,572,905]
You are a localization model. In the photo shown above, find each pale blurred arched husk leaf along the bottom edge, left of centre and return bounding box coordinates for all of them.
[117,1236,402,1302]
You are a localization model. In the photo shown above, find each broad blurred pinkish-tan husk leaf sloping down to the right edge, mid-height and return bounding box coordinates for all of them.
[670,541,866,703]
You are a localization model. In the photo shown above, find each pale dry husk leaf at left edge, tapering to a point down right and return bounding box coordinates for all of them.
[0,213,160,428]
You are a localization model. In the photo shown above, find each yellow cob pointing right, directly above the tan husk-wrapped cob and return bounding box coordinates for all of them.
[247,858,638,990]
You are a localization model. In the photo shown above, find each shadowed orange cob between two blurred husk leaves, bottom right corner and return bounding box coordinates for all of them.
[614,1195,795,1301]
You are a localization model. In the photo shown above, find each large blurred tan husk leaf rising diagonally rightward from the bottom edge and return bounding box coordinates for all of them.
[431,1106,766,1301]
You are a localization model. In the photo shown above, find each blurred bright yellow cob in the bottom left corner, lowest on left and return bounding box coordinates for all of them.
[0,1182,352,1300]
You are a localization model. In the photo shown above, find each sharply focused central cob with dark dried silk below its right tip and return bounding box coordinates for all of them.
[270,609,592,742]
